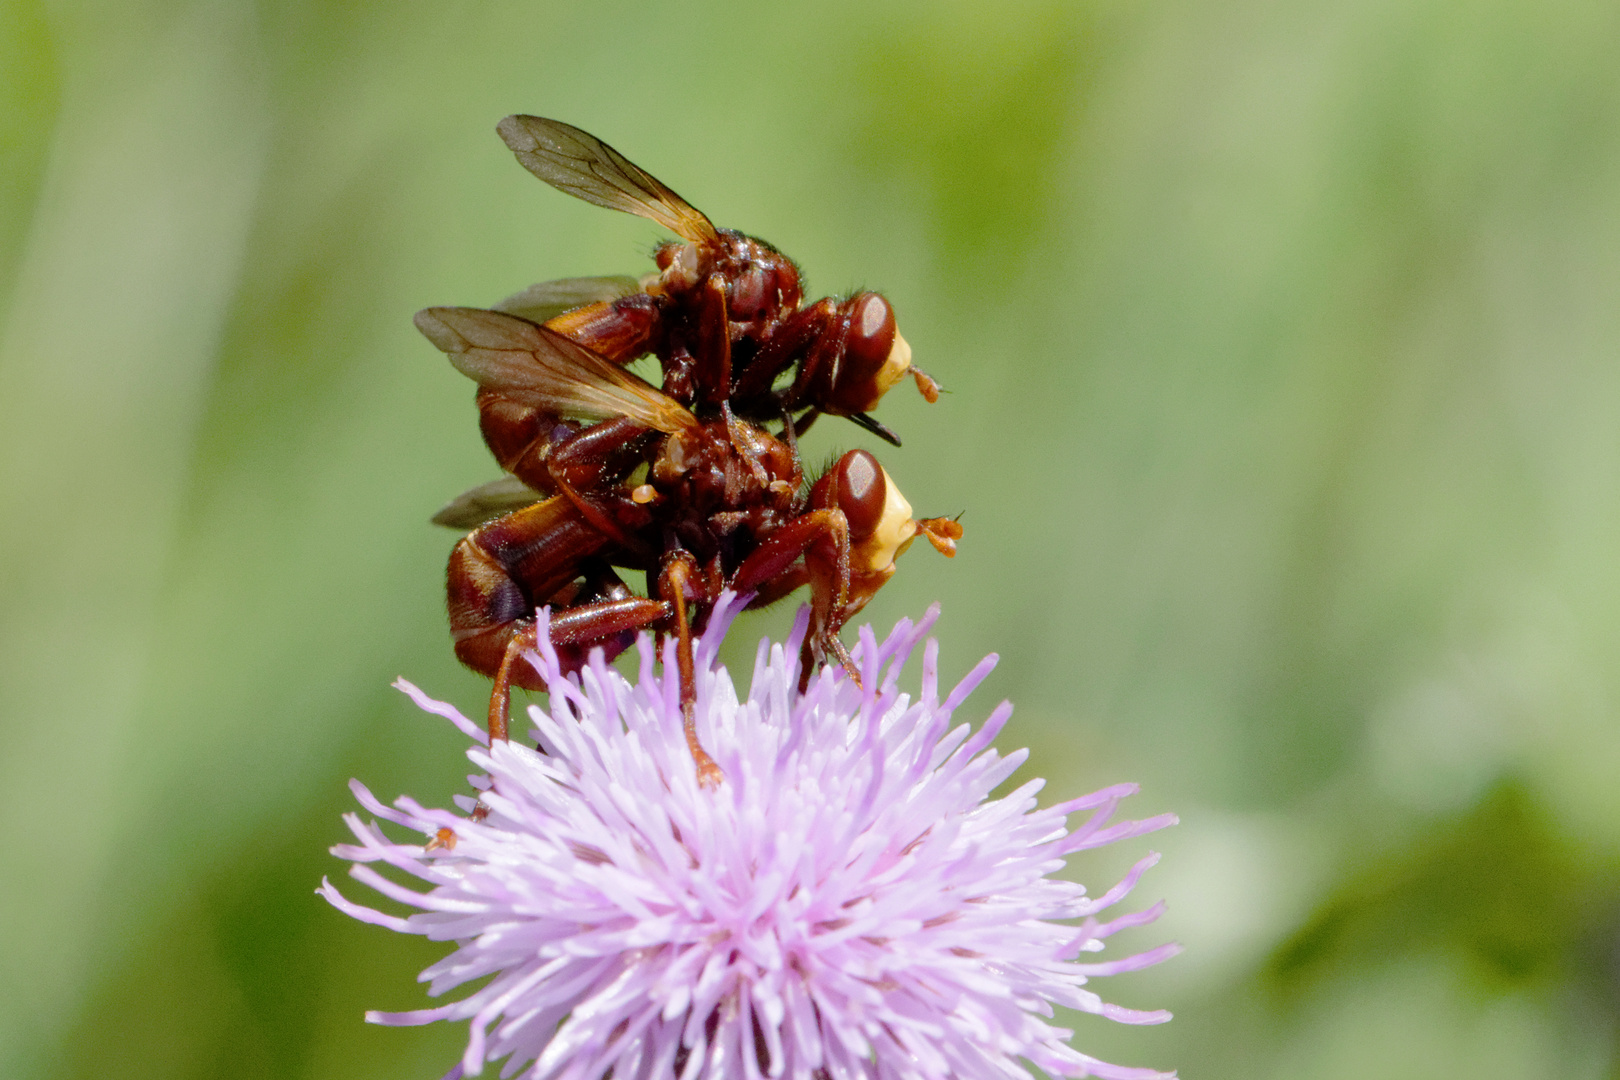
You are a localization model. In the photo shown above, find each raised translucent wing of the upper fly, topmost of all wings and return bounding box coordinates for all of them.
[496,117,719,243]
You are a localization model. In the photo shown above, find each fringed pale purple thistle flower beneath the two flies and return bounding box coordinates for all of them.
[321,597,1179,1080]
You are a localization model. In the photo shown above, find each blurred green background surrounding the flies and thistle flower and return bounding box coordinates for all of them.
[0,0,1620,1080]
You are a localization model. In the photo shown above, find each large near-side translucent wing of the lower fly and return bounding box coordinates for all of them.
[416,308,698,432]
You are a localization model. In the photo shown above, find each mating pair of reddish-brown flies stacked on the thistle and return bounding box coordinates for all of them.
[416,117,962,785]
